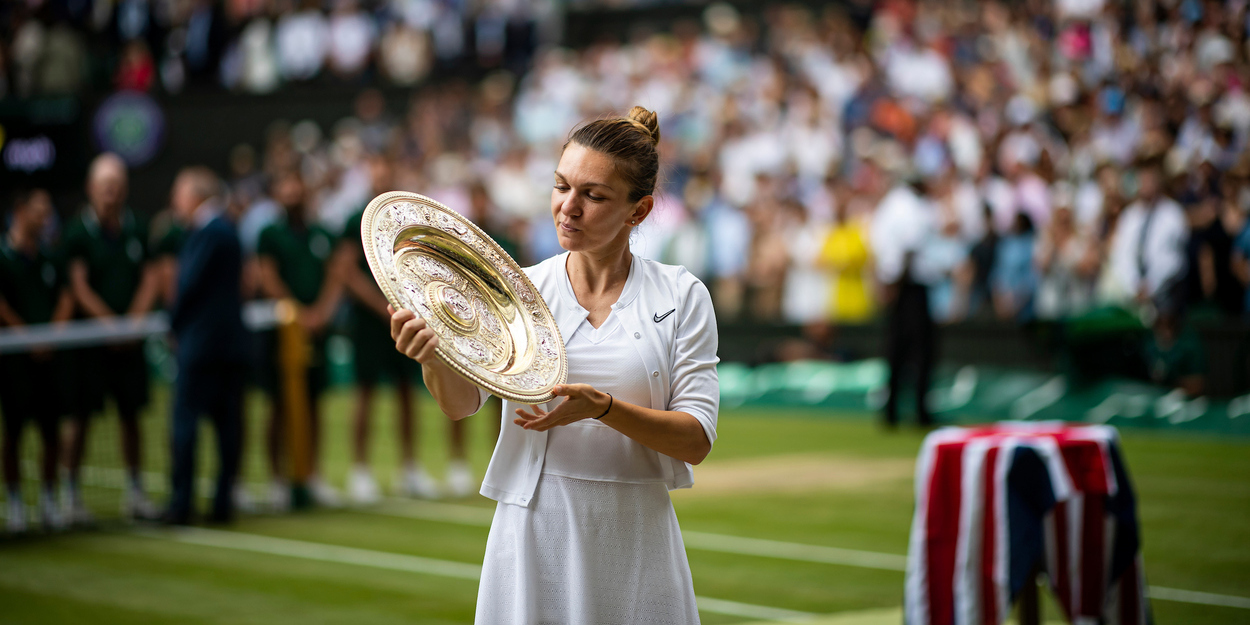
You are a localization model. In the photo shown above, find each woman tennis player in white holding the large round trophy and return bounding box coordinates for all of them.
[391,106,720,625]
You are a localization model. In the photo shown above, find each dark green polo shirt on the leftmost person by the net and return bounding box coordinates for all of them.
[0,238,65,324]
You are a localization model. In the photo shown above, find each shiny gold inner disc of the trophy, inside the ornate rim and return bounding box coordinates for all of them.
[394,225,538,375]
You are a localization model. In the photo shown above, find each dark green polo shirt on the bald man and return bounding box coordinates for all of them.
[65,208,149,315]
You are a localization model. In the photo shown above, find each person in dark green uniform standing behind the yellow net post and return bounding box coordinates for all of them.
[256,171,343,509]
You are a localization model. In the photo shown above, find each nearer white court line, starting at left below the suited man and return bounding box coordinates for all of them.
[131,525,819,623]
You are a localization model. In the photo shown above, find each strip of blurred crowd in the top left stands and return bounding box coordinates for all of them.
[0,0,559,99]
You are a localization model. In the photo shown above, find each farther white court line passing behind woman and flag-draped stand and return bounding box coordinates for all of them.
[370,498,1250,610]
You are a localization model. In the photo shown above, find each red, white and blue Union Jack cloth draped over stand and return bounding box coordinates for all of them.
[905,423,1150,625]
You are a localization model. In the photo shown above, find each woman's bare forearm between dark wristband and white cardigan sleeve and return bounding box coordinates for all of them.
[600,399,711,465]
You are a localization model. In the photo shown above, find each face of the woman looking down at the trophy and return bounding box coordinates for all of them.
[551,144,653,253]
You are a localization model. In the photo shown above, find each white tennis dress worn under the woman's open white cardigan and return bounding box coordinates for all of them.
[476,257,699,625]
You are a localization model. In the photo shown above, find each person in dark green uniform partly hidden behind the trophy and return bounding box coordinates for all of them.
[335,154,474,504]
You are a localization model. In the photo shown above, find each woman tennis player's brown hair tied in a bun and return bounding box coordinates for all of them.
[564,106,660,201]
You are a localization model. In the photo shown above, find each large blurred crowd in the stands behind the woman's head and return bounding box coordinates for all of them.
[173,0,1250,323]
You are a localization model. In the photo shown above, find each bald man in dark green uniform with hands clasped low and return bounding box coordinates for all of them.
[65,153,159,524]
